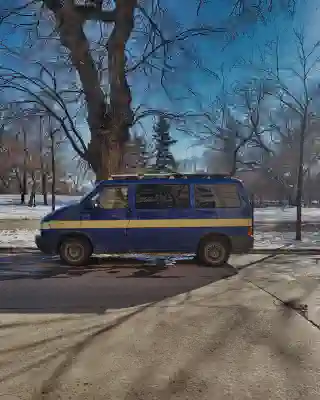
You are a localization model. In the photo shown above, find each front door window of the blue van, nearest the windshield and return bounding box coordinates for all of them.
[94,186,128,210]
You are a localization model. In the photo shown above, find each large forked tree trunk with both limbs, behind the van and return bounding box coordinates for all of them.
[45,0,137,180]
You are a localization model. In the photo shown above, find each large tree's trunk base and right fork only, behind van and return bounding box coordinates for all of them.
[88,0,137,180]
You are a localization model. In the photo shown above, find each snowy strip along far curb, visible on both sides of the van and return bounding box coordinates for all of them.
[0,229,320,249]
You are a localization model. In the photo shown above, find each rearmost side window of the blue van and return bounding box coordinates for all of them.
[195,184,241,208]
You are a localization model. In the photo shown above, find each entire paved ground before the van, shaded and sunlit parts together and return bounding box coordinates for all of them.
[0,255,320,400]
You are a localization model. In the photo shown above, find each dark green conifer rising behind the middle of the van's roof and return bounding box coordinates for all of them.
[153,116,177,171]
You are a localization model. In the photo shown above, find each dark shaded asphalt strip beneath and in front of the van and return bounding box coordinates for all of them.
[0,254,248,313]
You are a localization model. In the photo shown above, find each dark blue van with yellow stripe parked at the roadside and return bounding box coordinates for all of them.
[36,174,253,266]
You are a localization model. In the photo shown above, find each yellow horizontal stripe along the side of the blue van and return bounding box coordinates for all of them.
[41,218,252,229]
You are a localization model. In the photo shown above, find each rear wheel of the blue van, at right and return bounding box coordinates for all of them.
[197,237,231,267]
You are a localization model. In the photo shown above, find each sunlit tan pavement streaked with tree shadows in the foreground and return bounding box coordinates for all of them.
[0,252,320,400]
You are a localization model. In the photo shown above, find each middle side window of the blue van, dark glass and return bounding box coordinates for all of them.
[136,184,190,210]
